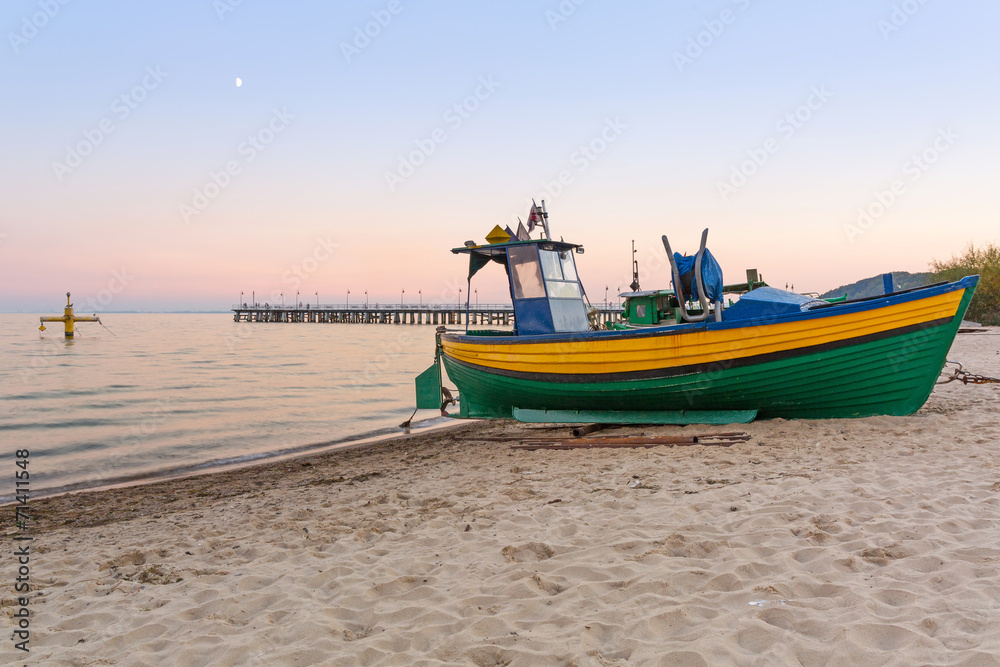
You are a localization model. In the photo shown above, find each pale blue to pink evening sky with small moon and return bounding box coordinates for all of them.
[0,0,1000,312]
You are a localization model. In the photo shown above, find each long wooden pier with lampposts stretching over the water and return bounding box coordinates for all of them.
[232,304,622,327]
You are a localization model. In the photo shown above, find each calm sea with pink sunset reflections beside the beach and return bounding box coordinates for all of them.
[0,313,450,501]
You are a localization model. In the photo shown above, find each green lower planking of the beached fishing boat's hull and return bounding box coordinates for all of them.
[442,289,973,419]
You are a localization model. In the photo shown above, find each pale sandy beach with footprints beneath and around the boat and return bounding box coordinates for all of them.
[0,329,1000,666]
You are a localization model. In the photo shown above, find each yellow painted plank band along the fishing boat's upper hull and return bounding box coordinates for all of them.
[441,290,964,374]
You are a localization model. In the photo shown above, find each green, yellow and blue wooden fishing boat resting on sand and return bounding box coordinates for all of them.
[416,202,979,424]
